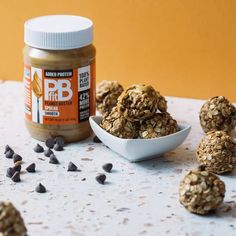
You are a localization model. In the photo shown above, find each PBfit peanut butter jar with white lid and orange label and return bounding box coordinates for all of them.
[24,15,96,142]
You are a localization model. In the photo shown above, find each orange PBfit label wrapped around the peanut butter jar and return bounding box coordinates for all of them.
[24,64,95,125]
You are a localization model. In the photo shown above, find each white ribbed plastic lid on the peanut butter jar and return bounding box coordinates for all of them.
[24,15,93,50]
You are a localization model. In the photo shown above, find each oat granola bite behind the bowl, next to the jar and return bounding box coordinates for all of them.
[96,80,124,114]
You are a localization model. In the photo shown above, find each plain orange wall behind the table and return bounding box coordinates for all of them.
[0,0,236,101]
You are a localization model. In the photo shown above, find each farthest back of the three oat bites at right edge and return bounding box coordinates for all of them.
[199,96,236,133]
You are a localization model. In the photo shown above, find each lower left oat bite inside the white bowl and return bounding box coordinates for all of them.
[100,107,139,139]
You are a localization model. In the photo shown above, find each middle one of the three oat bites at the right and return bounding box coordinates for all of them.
[197,131,236,174]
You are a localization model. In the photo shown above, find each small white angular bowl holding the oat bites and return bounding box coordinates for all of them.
[89,116,191,162]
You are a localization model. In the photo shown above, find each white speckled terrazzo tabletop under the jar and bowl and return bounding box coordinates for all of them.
[0,81,236,236]
